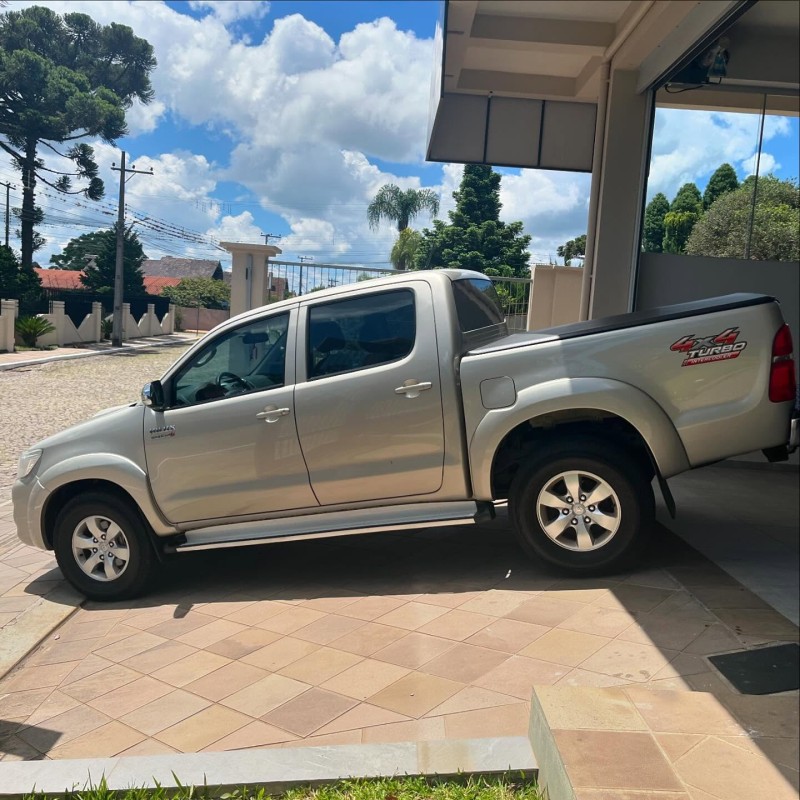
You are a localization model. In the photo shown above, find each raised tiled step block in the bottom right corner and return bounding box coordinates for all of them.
[533,686,798,800]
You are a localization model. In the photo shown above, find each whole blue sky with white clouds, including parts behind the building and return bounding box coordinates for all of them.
[0,0,798,267]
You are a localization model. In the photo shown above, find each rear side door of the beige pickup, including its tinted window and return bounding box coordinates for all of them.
[295,281,444,505]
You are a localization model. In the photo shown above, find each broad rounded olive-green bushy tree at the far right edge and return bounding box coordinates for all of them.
[686,175,800,261]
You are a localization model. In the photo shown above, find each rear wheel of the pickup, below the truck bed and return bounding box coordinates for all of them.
[509,439,655,575]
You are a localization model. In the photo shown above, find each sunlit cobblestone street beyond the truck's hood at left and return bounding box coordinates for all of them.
[0,346,191,503]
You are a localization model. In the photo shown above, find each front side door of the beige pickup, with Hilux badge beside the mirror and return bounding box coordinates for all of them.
[144,308,319,522]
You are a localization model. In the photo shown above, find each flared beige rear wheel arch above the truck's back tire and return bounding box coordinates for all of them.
[470,378,689,499]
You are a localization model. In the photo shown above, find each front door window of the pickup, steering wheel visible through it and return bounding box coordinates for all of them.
[174,314,289,406]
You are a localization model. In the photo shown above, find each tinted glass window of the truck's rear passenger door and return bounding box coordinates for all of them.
[308,289,416,378]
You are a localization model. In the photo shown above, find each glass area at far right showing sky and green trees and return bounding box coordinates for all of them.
[642,99,800,261]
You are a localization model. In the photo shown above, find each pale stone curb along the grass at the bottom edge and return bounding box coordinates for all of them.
[0,736,537,800]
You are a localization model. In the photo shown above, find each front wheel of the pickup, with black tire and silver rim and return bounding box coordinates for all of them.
[53,492,158,600]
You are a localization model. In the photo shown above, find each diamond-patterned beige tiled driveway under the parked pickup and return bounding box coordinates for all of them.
[0,518,798,776]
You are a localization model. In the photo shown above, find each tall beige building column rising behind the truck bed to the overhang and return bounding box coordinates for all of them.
[585,70,652,319]
